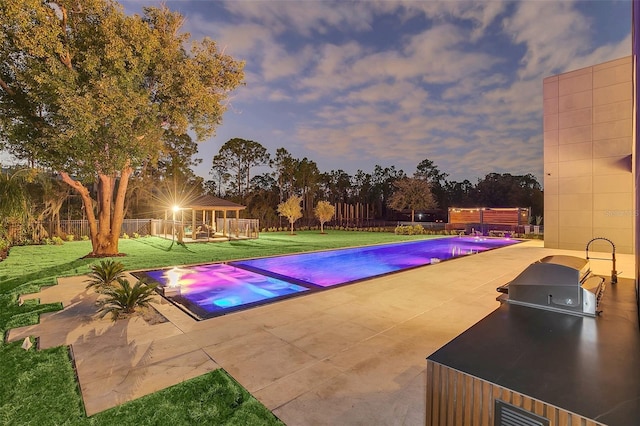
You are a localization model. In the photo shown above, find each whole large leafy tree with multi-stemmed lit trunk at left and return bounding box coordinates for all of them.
[0,0,244,256]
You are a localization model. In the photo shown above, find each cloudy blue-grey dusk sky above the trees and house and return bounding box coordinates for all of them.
[122,0,631,183]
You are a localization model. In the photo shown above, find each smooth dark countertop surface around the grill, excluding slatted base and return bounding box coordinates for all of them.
[427,279,640,426]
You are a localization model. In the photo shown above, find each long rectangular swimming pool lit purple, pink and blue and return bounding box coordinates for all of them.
[132,237,520,319]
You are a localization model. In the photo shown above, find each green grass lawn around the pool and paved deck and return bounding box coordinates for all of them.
[0,231,440,425]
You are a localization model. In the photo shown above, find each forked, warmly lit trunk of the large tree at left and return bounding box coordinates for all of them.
[60,162,133,257]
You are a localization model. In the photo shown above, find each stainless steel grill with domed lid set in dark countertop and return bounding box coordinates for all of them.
[498,255,605,316]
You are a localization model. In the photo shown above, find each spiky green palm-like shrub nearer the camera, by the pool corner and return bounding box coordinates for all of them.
[99,277,157,321]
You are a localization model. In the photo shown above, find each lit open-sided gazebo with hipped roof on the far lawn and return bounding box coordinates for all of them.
[174,195,247,240]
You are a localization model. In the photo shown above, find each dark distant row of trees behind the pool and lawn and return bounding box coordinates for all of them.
[204,138,543,228]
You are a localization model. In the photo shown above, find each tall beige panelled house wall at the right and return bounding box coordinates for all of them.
[543,56,636,253]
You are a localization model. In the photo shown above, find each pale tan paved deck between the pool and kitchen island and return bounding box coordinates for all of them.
[8,241,634,426]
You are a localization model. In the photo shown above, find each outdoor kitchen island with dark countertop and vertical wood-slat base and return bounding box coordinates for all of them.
[426,279,640,426]
